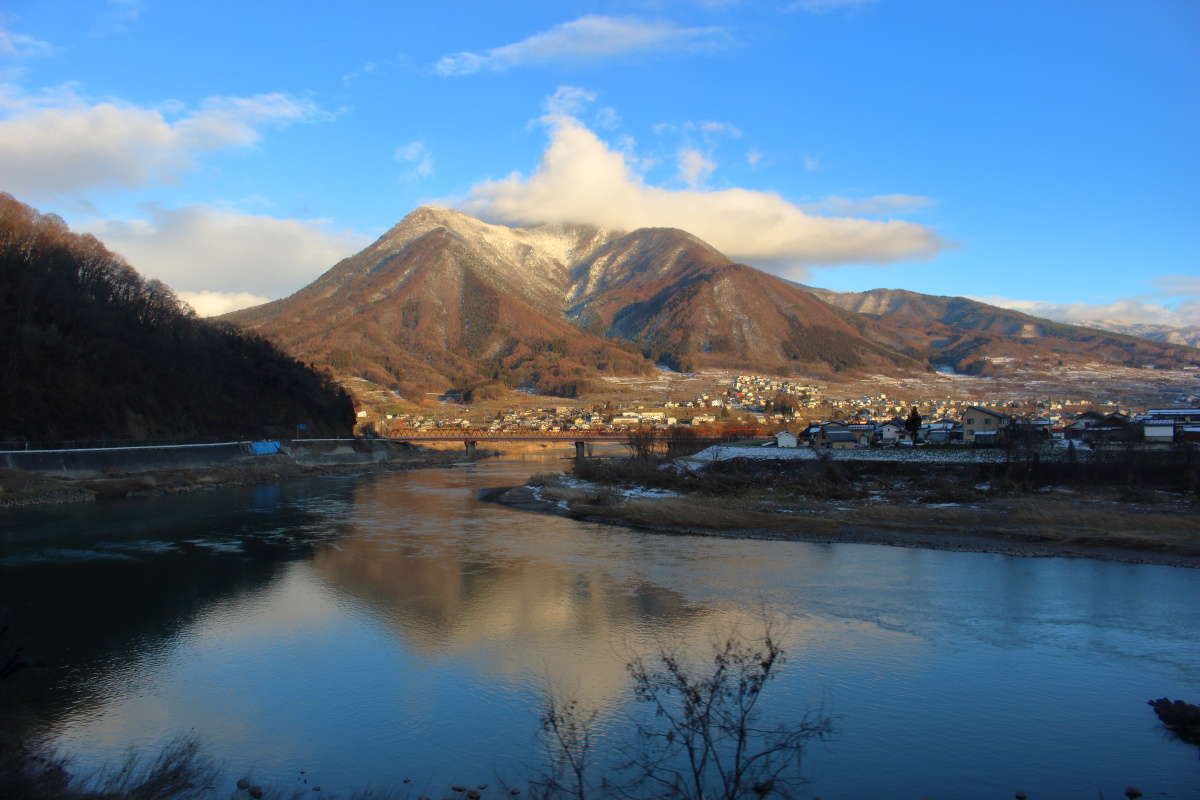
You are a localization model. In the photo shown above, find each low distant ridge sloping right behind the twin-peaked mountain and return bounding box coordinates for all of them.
[805,287,1200,374]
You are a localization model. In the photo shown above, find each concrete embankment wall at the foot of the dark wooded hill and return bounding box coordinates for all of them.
[0,440,412,477]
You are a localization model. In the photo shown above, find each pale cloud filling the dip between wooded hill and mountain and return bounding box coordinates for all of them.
[76,205,368,303]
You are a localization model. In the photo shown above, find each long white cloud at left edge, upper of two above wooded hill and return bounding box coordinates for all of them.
[0,85,331,198]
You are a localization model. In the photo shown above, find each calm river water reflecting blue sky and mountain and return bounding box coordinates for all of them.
[0,453,1200,800]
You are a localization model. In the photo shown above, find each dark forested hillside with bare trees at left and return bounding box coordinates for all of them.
[0,193,354,443]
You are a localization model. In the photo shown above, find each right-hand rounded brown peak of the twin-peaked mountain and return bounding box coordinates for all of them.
[566,228,923,374]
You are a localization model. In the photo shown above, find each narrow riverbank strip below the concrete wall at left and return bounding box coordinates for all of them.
[0,440,482,512]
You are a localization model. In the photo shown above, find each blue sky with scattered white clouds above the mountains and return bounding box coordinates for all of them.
[0,0,1200,324]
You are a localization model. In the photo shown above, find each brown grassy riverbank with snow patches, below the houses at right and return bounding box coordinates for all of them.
[481,475,1200,569]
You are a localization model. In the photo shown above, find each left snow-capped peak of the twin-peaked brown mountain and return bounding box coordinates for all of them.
[224,207,650,397]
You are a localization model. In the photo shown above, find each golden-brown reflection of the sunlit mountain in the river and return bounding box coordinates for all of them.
[313,472,792,704]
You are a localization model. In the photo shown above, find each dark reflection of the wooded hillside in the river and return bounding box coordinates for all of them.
[0,482,354,743]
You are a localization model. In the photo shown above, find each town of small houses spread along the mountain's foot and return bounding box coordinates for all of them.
[358,374,1200,449]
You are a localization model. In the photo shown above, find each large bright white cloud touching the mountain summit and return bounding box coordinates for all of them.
[458,116,946,277]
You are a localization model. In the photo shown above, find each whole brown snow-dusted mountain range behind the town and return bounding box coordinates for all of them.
[224,206,1200,396]
